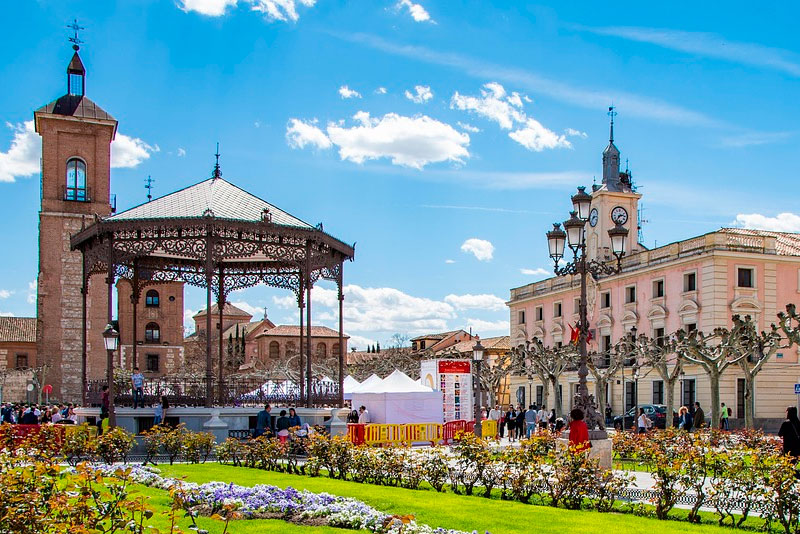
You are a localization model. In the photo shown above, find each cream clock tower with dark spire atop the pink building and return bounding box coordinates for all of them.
[586,106,643,261]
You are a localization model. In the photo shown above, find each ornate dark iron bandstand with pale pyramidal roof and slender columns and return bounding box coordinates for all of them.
[70,170,355,407]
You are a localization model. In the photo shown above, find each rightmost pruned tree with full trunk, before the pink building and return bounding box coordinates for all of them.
[732,314,791,428]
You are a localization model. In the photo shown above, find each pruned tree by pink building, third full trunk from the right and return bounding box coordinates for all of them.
[617,334,684,428]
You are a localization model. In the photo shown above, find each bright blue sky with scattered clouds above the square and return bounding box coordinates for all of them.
[0,0,800,347]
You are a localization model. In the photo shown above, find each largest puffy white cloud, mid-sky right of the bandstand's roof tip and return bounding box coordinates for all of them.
[327,111,469,169]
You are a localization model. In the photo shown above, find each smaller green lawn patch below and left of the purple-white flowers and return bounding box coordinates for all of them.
[131,485,354,534]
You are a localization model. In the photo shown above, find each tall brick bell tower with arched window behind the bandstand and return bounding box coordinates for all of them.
[34,40,117,402]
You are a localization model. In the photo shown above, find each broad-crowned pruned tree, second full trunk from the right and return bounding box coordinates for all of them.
[675,321,748,427]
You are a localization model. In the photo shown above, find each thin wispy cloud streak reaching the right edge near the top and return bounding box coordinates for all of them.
[577,26,800,77]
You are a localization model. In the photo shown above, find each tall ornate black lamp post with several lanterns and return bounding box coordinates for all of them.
[547,187,628,439]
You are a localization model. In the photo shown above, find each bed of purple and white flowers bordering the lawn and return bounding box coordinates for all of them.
[93,465,484,534]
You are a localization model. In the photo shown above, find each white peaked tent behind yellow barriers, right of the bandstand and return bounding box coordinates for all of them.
[352,370,443,423]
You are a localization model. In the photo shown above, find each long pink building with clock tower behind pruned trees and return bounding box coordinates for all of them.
[507,126,800,428]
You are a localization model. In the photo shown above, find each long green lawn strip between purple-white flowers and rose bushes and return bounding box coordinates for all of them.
[159,464,752,534]
